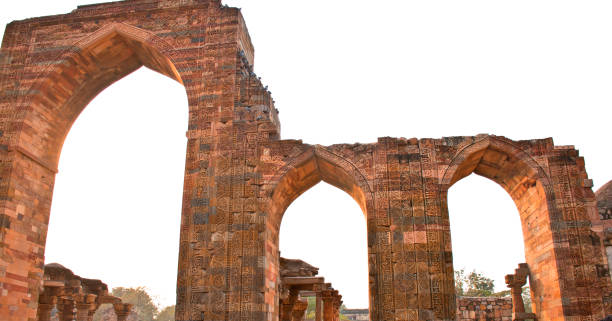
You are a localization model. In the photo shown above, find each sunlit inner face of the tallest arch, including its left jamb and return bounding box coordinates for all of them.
[0,19,186,320]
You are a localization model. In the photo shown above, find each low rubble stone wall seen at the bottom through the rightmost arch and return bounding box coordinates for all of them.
[457,297,512,321]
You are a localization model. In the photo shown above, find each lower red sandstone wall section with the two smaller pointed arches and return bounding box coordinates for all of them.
[258,135,610,320]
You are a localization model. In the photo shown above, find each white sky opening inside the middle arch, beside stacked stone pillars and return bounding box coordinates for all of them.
[279,183,369,309]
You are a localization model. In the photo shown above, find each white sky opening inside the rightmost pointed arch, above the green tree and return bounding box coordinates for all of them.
[448,174,527,296]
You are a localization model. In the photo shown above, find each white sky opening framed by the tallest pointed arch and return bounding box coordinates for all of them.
[45,68,188,305]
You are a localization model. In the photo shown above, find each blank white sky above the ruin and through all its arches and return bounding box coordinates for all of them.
[0,0,612,307]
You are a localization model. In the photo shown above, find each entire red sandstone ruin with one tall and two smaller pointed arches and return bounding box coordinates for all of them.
[0,0,612,321]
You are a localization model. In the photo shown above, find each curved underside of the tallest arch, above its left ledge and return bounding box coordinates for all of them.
[18,23,183,171]
